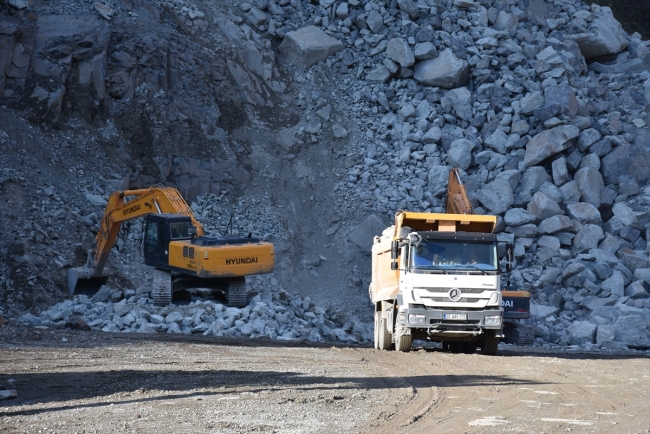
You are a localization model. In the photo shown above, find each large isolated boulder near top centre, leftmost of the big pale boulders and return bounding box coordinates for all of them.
[279,26,343,71]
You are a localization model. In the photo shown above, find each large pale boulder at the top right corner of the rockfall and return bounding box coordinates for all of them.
[567,7,628,59]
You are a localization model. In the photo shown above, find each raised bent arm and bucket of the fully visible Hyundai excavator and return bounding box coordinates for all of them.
[68,187,204,295]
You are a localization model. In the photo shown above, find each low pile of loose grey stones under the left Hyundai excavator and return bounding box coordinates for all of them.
[19,277,373,345]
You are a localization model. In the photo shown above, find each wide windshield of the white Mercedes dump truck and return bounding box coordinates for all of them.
[411,240,499,271]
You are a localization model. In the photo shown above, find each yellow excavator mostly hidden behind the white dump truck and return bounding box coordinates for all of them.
[445,168,535,345]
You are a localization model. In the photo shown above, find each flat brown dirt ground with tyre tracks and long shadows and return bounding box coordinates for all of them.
[0,328,650,434]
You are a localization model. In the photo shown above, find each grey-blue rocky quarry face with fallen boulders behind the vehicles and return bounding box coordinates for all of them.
[0,0,650,347]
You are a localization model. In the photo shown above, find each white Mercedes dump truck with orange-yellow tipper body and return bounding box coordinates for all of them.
[369,168,503,355]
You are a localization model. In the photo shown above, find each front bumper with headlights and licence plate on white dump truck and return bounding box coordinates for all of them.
[397,307,503,335]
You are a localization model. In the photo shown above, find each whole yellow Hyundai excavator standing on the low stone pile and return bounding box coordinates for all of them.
[68,187,274,307]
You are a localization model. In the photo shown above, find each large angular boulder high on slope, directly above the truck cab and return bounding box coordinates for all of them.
[413,48,469,89]
